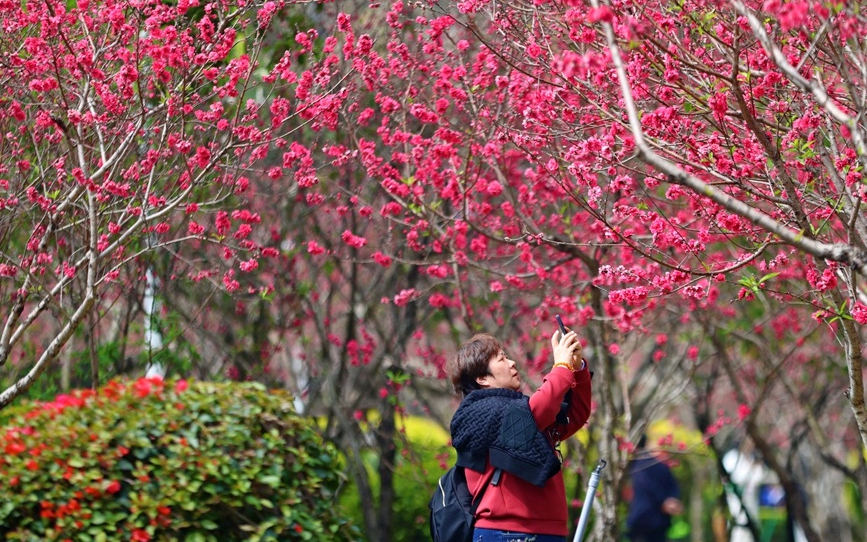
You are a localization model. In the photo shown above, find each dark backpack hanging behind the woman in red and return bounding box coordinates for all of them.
[428,466,499,542]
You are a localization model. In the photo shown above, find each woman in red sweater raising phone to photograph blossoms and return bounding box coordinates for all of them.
[451,330,590,542]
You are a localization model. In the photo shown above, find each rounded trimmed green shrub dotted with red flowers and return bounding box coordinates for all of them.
[0,379,357,542]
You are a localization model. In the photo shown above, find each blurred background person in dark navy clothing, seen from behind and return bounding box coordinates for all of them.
[626,435,683,542]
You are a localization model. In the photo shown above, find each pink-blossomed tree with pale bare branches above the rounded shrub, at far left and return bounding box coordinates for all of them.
[0,0,362,406]
